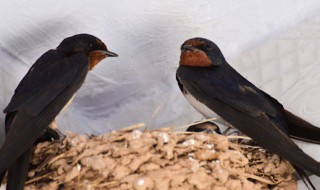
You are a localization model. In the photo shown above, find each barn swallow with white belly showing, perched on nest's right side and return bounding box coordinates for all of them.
[176,38,320,189]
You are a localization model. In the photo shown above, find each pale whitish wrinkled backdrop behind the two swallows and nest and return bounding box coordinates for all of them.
[0,0,320,189]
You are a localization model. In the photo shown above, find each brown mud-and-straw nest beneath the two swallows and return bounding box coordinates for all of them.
[19,125,297,190]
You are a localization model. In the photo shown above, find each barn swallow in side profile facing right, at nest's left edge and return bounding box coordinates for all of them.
[0,34,117,190]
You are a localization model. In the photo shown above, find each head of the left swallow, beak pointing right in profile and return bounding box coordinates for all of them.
[57,34,118,70]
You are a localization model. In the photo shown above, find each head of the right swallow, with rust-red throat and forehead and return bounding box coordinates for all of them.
[179,38,225,67]
